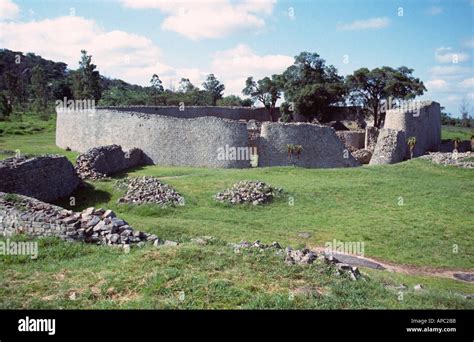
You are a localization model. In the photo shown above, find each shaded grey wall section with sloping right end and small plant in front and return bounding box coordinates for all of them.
[258,122,360,168]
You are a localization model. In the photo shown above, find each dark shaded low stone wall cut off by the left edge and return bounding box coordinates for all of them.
[0,155,80,202]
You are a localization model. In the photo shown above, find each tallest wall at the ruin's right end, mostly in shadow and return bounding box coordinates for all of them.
[384,101,441,157]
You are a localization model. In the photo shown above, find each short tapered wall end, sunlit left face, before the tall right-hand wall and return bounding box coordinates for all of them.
[369,128,408,165]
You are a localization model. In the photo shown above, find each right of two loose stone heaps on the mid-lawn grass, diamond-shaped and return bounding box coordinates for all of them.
[214,181,283,205]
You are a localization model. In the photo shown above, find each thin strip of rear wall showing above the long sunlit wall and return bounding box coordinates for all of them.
[94,106,280,122]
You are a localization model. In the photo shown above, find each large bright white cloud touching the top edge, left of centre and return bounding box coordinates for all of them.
[122,0,275,40]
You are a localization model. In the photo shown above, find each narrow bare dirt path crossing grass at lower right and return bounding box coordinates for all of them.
[312,247,474,283]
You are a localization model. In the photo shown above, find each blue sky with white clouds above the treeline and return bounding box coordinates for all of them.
[0,0,474,116]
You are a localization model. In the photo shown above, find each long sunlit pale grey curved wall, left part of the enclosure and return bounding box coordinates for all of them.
[56,109,250,168]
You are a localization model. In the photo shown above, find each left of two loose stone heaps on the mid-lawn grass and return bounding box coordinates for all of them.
[117,176,184,207]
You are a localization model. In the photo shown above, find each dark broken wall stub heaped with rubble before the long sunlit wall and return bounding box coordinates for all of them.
[76,145,147,180]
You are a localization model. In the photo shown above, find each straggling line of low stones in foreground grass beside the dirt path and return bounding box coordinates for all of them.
[230,240,361,280]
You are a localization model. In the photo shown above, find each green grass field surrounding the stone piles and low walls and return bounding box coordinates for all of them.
[0,119,474,309]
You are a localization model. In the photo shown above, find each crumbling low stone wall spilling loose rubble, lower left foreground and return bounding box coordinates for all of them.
[0,193,177,248]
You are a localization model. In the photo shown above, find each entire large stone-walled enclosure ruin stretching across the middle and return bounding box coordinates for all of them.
[56,102,441,168]
